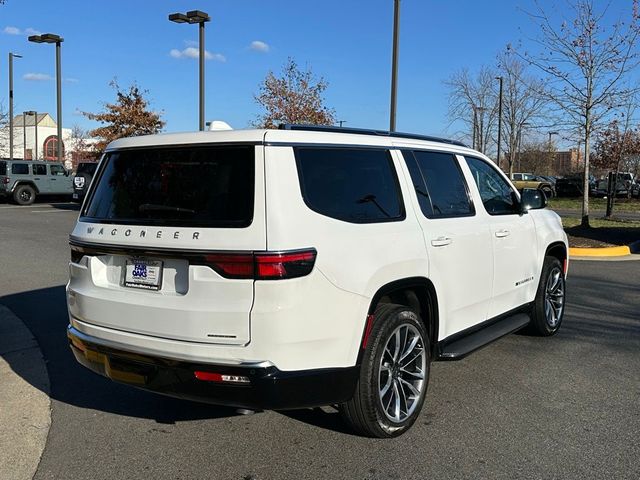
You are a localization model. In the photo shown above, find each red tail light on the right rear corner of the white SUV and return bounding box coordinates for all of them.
[203,249,316,280]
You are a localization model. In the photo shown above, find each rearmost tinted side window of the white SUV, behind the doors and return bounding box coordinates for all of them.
[295,147,405,223]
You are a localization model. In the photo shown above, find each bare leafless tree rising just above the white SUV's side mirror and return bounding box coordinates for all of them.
[498,52,548,176]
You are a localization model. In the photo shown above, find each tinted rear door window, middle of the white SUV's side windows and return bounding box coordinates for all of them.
[403,150,475,218]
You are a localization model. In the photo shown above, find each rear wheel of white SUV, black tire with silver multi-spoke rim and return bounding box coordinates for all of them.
[340,304,431,438]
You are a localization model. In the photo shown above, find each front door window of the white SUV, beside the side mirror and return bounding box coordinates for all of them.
[465,157,520,215]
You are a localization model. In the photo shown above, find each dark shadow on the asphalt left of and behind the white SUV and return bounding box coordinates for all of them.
[0,285,238,424]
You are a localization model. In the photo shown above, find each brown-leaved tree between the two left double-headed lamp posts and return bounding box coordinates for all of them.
[82,79,164,152]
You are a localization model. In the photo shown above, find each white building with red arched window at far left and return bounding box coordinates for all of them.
[0,112,72,168]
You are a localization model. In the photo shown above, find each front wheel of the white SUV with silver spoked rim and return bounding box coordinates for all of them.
[528,257,566,337]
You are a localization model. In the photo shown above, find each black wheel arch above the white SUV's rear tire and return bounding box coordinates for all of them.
[358,277,439,364]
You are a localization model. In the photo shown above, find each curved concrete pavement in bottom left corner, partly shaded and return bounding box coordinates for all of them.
[0,305,51,480]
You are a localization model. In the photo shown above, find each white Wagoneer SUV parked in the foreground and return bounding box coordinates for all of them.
[67,125,568,437]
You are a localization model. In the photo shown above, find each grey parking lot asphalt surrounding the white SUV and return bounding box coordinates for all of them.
[0,204,640,480]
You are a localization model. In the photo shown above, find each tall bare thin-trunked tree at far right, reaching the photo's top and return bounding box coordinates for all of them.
[521,0,640,227]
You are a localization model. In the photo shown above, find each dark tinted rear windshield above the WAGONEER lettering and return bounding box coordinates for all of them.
[82,145,255,228]
